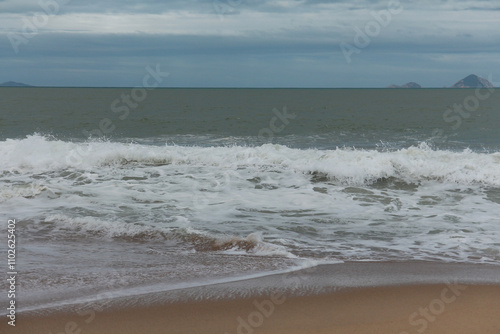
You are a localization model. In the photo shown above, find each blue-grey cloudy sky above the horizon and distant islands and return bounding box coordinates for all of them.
[0,0,500,88]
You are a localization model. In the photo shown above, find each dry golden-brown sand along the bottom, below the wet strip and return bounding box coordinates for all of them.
[4,284,500,334]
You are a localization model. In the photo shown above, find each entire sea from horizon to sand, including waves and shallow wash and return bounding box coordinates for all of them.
[0,88,500,310]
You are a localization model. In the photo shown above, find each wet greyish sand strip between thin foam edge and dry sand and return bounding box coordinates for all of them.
[8,261,500,316]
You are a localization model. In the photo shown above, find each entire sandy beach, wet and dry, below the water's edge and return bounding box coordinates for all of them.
[0,264,500,334]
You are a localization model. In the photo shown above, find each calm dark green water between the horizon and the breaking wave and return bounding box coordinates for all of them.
[0,88,500,149]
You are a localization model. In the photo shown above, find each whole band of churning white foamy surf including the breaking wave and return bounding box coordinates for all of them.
[0,135,500,276]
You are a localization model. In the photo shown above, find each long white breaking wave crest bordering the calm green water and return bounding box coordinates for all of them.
[0,135,500,186]
